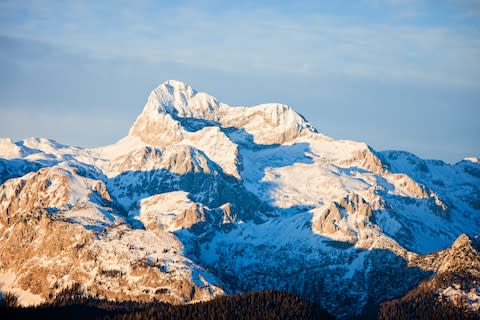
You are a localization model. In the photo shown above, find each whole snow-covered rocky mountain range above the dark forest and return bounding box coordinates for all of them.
[0,80,480,318]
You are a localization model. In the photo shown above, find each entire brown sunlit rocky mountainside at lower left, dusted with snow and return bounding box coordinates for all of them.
[0,168,223,305]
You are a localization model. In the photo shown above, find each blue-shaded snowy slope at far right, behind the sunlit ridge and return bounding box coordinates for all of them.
[380,151,480,253]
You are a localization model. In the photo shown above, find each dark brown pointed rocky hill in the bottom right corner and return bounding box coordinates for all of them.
[380,234,480,319]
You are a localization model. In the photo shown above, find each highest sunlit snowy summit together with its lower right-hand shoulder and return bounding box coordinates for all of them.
[129,80,316,146]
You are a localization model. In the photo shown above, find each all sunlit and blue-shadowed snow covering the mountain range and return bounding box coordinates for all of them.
[0,80,480,316]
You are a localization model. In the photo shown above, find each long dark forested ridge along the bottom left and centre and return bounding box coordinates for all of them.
[0,286,334,320]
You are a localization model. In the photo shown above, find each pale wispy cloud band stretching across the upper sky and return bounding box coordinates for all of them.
[2,1,480,87]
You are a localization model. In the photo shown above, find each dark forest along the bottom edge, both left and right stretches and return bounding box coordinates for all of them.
[0,285,480,320]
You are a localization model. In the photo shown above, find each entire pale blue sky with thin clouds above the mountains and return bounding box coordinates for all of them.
[0,0,480,162]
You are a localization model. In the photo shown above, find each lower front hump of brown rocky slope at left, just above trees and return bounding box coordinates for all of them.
[0,216,223,305]
